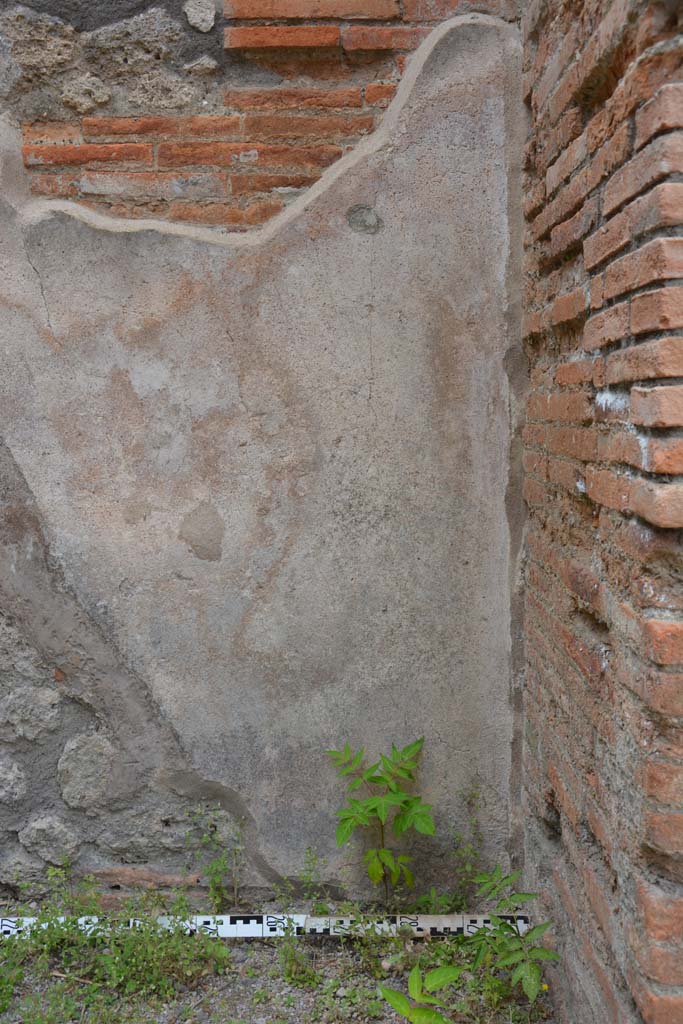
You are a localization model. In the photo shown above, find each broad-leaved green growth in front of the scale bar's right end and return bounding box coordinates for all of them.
[380,867,559,1024]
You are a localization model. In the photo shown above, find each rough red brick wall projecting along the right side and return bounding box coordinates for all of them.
[522,0,683,1024]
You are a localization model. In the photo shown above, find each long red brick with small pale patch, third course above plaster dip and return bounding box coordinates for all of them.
[159,142,342,170]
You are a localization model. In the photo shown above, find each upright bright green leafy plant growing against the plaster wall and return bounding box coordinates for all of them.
[327,737,434,902]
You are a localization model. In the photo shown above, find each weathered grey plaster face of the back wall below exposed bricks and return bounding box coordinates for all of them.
[0,15,521,897]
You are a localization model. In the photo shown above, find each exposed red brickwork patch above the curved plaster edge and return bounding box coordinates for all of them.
[18,0,516,230]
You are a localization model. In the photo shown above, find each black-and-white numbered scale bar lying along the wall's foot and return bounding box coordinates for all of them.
[0,913,529,939]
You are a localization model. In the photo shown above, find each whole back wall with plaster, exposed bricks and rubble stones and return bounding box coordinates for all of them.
[0,3,523,905]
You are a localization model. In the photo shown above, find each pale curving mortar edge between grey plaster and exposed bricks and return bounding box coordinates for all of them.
[7,13,519,249]
